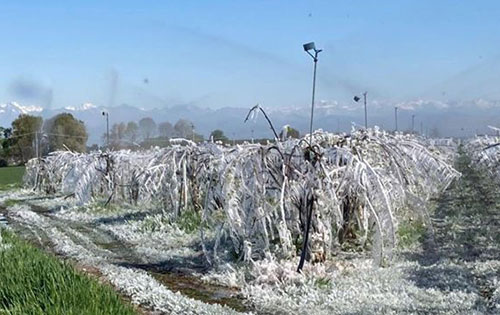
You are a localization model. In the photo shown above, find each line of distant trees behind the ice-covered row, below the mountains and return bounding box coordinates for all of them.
[0,113,299,167]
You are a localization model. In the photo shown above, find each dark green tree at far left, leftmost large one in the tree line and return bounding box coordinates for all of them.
[10,114,43,163]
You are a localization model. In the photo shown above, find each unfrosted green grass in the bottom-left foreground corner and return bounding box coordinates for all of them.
[0,230,135,314]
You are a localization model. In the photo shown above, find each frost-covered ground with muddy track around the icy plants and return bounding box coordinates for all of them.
[0,149,500,314]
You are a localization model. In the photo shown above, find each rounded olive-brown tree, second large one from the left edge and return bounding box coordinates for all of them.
[44,113,88,152]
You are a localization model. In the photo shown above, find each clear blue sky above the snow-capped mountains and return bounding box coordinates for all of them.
[0,0,500,108]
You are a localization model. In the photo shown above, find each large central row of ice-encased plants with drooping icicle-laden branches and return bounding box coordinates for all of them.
[25,128,460,265]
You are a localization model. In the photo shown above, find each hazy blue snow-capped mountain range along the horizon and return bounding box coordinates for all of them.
[0,99,500,144]
